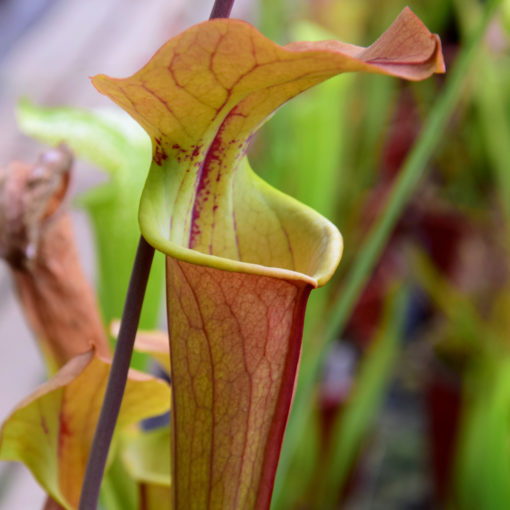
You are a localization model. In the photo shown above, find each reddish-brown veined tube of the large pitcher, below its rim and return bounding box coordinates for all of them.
[167,257,312,510]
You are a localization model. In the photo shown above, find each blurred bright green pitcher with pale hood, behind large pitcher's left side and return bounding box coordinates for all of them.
[17,99,164,358]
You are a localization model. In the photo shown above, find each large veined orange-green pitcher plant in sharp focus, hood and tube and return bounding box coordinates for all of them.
[93,9,444,510]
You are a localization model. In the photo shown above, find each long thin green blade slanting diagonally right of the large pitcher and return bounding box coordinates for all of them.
[272,0,502,509]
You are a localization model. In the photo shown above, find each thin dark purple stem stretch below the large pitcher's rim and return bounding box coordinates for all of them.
[79,237,154,510]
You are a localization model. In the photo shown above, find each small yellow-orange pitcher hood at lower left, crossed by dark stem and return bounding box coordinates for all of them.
[0,351,170,510]
